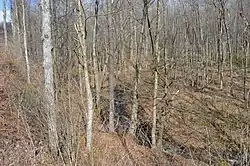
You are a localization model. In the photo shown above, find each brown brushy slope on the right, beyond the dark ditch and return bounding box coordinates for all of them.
[115,60,250,166]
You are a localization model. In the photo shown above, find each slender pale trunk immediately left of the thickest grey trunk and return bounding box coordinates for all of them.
[22,0,30,84]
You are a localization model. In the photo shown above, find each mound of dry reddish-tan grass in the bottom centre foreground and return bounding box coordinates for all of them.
[82,132,206,166]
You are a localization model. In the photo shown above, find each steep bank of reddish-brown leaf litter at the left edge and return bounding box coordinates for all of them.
[0,51,44,166]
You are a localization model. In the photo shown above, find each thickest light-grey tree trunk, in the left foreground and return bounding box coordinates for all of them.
[41,0,58,154]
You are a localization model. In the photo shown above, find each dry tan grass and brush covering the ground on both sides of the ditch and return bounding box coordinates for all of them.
[0,44,250,166]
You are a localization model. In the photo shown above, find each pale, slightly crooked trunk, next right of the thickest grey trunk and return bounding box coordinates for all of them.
[76,0,93,152]
